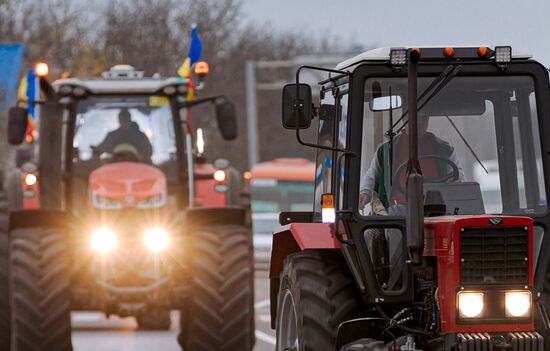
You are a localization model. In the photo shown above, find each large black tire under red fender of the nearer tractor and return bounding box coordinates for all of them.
[276,250,360,351]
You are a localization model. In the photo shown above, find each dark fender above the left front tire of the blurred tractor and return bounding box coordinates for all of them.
[9,210,71,231]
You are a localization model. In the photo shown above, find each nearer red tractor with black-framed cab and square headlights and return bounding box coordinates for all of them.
[270,46,550,351]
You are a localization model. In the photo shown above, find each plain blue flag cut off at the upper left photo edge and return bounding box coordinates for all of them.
[0,44,23,112]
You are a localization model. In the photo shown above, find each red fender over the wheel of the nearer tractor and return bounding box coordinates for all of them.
[269,223,340,329]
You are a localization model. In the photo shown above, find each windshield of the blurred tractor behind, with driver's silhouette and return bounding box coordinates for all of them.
[73,96,176,165]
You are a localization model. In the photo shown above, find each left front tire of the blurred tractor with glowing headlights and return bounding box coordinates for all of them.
[10,227,72,351]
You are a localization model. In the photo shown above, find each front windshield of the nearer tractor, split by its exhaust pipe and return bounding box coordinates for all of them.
[359,76,547,215]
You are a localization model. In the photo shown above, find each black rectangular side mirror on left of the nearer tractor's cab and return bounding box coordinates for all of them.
[283,84,313,129]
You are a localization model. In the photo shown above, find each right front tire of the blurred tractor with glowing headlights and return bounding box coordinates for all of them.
[178,225,255,351]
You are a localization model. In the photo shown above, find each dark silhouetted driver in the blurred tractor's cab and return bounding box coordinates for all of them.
[93,109,153,162]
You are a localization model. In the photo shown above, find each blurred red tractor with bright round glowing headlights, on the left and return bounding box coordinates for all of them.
[0,65,255,350]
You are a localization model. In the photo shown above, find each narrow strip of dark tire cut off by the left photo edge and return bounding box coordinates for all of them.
[0,192,11,351]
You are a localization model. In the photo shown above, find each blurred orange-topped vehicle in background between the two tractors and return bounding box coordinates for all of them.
[250,158,315,269]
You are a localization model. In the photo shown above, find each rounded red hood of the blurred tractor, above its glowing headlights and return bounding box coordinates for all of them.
[89,162,166,208]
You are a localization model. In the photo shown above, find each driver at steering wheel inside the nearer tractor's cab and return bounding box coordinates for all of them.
[359,114,465,215]
